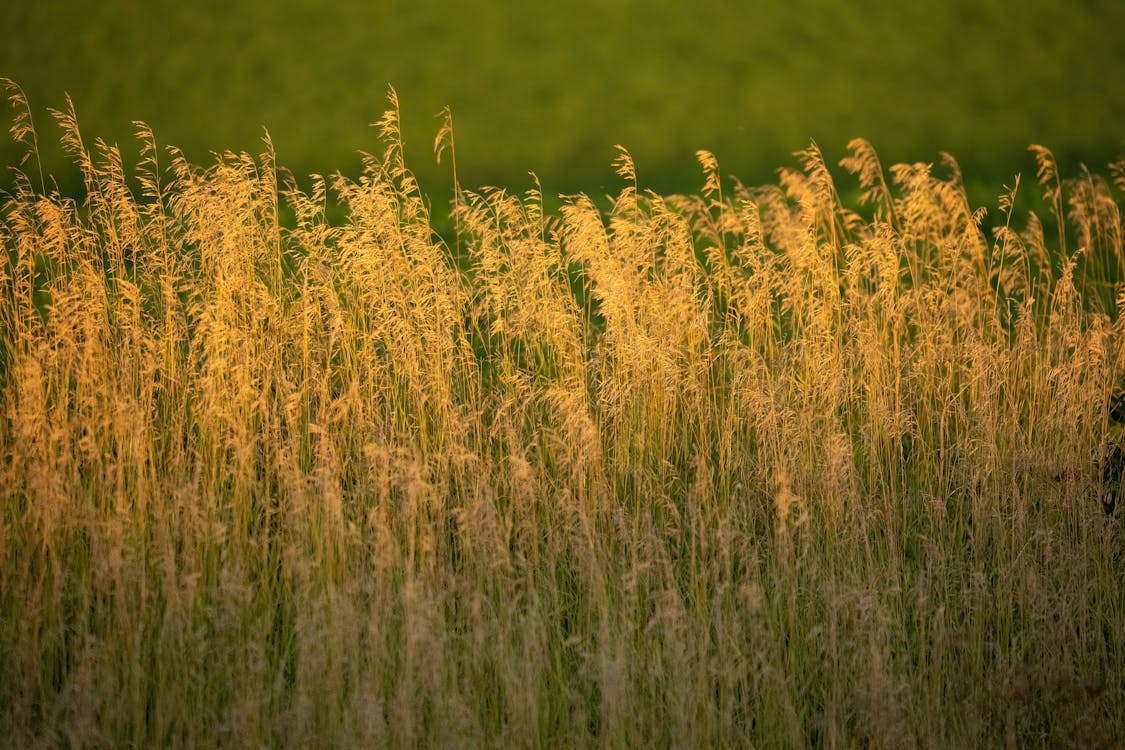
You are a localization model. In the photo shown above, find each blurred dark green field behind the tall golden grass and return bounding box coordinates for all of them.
[0,0,1125,195]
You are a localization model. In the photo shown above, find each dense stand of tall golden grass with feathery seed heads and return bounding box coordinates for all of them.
[0,86,1125,747]
